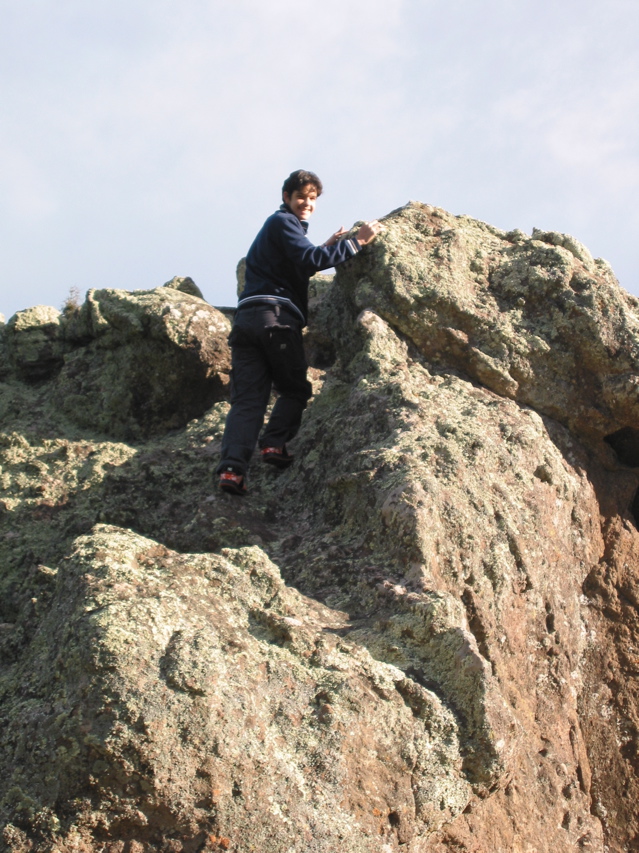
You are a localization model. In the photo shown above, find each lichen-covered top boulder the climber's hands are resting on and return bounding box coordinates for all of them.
[335,203,639,452]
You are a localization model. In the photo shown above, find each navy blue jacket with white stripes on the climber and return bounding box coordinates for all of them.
[240,204,360,324]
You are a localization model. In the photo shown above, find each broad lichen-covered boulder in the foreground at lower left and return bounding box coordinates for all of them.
[0,526,471,853]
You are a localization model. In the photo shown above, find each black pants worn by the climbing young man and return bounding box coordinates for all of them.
[217,304,312,474]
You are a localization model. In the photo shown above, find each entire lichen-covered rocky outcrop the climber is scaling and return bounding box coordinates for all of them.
[0,204,639,853]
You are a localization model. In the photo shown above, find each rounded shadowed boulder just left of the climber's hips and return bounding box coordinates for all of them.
[54,286,230,439]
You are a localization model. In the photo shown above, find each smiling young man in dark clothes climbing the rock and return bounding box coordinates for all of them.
[217,169,382,495]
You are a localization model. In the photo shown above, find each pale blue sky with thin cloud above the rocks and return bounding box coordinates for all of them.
[0,0,639,319]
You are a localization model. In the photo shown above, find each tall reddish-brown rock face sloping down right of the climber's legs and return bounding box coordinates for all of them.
[272,311,608,851]
